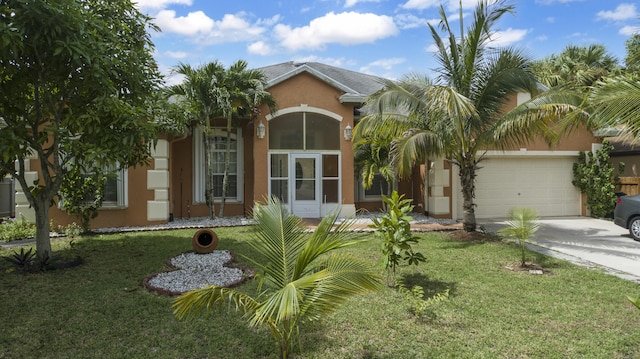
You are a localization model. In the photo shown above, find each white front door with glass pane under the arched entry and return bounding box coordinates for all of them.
[289,153,321,218]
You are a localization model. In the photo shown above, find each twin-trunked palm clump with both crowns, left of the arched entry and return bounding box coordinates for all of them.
[166,60,275,218]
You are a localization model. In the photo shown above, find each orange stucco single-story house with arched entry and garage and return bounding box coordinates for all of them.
[16,62,601,227]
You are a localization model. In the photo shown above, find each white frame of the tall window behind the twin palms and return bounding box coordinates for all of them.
[193,126,244,204]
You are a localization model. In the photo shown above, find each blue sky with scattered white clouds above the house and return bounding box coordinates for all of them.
[134,0,640,84]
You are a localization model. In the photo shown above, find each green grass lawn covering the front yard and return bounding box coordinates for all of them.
[0,227,640,358]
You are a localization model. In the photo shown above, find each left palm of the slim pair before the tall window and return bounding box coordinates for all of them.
[165,61,225,219]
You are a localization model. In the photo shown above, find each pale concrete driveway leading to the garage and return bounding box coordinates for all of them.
[478,217,640,283]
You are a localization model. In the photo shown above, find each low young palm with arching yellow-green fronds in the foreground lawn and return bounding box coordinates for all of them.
[174,197,381,358]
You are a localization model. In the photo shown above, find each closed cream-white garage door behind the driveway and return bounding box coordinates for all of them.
[458,157,581,218]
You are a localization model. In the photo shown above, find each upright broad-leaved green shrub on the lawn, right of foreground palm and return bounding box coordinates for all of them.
[369,191,426,285]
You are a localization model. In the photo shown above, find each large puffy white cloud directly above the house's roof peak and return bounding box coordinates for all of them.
[274,12,398,50]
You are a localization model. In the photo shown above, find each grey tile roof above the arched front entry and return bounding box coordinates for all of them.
[256,61,384,103]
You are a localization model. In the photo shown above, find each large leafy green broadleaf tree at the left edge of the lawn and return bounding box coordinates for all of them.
[0,0,161,261]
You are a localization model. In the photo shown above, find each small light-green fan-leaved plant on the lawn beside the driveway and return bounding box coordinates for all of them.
[498,207,540,267]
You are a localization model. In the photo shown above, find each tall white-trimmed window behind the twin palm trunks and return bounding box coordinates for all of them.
[193,128,243,203]
